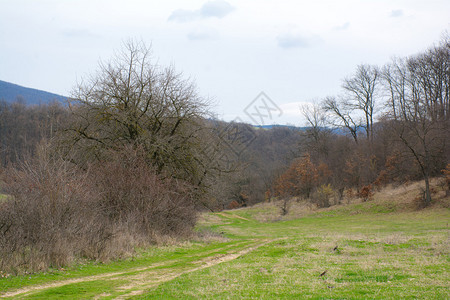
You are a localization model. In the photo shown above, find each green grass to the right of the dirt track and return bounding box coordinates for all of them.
[134,209,450,299]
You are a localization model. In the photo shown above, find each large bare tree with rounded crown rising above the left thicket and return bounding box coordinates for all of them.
[63,41,220,199]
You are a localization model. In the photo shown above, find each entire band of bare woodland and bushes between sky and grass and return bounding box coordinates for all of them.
[0,36,450,273]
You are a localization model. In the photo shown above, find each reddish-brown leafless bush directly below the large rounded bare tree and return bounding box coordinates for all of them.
[91,147,196,241]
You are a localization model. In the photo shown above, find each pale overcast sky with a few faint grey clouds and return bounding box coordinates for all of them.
[0,0,450,126]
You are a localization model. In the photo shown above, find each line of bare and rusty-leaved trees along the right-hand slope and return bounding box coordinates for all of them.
[268,35,450,206]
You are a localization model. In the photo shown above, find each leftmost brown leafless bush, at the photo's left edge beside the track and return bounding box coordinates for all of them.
[0,149,101,273]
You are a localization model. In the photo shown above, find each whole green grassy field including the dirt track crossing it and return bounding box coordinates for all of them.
[0,186,450,299]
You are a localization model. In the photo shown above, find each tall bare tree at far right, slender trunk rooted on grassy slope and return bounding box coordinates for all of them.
[383,35,450,205]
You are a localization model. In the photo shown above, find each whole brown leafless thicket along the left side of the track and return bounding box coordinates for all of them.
[0,147,195,274]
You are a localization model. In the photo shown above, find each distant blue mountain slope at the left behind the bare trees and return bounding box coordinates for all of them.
[0,80,67,105]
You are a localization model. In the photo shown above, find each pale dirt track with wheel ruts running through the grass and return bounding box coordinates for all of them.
[0,239,278,299]
